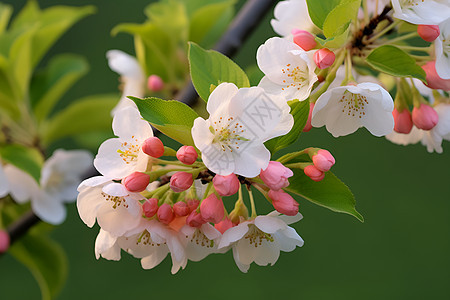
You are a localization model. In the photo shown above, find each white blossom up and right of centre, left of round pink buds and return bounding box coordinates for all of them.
[256,37,317,101]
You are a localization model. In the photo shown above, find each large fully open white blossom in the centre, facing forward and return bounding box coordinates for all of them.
[192,83,294,177]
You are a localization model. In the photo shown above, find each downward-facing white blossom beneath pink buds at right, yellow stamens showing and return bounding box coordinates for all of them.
[311,82,394,137]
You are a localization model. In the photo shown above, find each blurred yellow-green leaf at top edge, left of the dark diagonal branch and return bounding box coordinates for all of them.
[189,0,236,47]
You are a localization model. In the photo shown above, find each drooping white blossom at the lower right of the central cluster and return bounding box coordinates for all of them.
[218,212,303,273]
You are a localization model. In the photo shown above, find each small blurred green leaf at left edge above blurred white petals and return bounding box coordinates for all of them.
[0,144,44,184]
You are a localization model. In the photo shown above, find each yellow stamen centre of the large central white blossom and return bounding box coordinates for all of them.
[209,117,248,152]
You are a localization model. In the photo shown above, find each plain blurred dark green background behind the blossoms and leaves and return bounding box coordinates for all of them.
[0,0,450,300]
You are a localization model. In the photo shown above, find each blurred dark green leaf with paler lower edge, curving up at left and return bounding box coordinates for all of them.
[30,54,89,121]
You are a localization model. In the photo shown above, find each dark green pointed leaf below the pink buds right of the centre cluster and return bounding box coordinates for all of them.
[285,169,364,222]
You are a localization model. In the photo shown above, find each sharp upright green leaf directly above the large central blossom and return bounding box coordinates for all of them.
[188,43,250,101]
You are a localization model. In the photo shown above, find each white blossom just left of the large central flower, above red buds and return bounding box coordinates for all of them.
[94,107,153,180]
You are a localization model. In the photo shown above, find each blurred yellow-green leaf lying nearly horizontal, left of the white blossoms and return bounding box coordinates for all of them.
[41,94,120,145]
